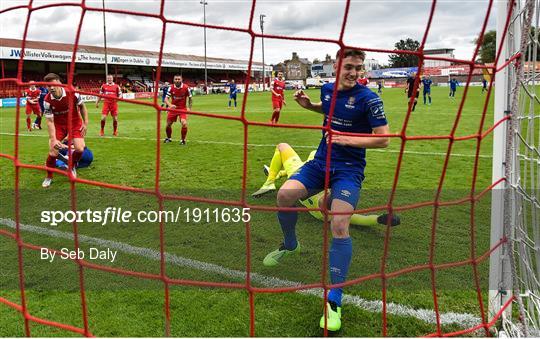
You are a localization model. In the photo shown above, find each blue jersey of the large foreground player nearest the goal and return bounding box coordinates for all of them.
[315,83,388,173]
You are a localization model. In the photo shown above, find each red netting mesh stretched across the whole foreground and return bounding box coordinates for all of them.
[0,0,519,337]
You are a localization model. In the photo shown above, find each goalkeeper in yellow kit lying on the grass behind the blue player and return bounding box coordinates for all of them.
[252,143,400,226]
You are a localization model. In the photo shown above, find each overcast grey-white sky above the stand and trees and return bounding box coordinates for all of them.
[0,0,497,64]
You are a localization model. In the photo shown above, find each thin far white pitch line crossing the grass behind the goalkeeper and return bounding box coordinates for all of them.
[0,132,492,159]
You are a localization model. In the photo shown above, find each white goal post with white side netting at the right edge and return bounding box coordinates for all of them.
[489,0,540,337]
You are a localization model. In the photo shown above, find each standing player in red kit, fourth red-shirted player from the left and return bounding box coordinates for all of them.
[164,74,192,145]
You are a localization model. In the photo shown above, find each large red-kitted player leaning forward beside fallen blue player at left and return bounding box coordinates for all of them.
[42,73,88,188]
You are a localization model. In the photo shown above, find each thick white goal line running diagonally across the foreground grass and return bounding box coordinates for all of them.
[0,218,481,328]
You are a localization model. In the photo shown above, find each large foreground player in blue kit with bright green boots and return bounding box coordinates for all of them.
[263,49,389,331]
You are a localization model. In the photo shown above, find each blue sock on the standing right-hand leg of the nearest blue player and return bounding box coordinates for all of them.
[328,237,352,306]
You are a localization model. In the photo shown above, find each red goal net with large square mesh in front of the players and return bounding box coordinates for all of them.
[0,0,520,337]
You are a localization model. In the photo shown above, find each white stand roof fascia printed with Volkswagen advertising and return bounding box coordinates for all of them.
[0,38,262,71]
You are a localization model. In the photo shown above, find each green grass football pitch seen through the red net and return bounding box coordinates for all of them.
[0,87,500,337]
